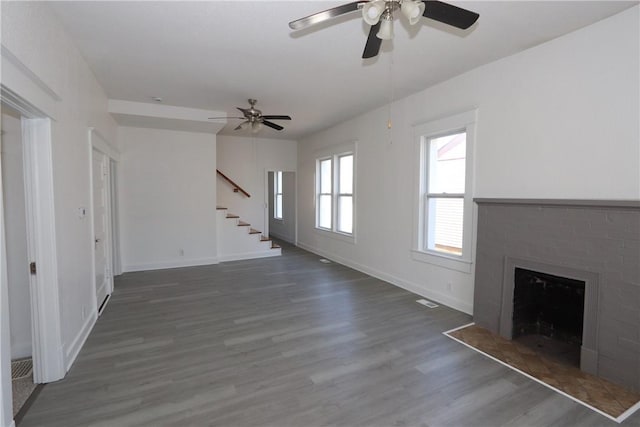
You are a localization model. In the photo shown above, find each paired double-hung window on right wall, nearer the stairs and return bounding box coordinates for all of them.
[316,146,354,236]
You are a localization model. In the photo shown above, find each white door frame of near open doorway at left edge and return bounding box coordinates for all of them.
[0,85,65,388]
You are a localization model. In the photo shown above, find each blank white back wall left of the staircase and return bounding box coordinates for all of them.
[118,127,217,271]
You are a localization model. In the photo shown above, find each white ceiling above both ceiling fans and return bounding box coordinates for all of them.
[48,0,638,139]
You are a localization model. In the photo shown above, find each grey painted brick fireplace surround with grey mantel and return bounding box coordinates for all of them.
[474,199,640,391]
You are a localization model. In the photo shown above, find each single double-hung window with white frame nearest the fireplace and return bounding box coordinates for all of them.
[413,111,475,271]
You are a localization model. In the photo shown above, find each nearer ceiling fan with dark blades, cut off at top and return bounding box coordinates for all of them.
[289,0,480,59]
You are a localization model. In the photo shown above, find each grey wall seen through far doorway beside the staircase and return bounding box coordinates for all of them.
[268,172,296,244]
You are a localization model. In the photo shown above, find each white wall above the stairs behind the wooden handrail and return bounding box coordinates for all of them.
[218,136,298,236]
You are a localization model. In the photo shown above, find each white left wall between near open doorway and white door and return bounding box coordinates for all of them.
[1,2,115,422]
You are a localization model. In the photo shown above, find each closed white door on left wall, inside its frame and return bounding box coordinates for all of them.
[92,150,110,313]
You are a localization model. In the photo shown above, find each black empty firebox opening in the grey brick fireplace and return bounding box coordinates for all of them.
[512,267,585,368]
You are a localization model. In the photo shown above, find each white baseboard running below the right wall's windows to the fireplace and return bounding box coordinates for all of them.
[297,242,473,314]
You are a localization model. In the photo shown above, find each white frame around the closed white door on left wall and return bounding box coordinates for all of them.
[88,127,120,317]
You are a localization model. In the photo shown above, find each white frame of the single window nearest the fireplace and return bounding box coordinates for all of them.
[411,110,477,273]
